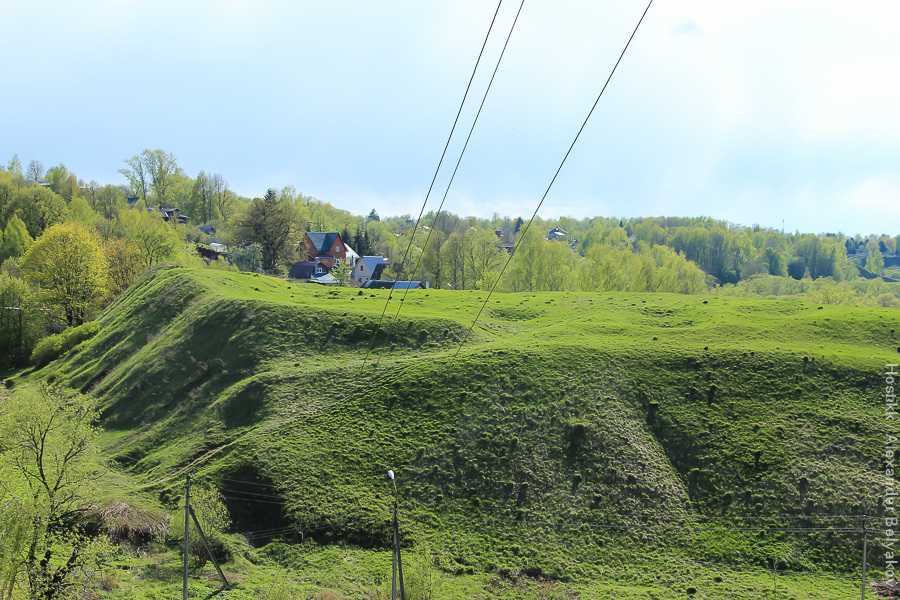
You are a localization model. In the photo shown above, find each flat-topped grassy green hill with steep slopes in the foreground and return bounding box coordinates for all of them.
[35,268,900,598]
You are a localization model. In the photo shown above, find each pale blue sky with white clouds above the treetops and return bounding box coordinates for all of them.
[0,0,900,234]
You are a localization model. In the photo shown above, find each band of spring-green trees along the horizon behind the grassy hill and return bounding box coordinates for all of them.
[0,149,900,364]
